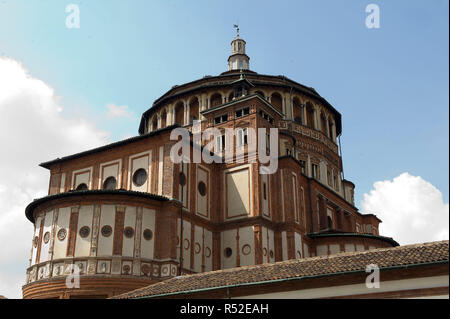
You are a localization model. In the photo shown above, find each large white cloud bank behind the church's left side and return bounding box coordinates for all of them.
[0,57,108,298]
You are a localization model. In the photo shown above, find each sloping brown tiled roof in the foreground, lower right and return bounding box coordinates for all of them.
[114,240,449,299]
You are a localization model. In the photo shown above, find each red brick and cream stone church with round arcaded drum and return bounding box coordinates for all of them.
[23,33,398,298]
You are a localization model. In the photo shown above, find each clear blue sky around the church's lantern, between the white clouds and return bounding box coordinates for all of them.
[0,0,449,204]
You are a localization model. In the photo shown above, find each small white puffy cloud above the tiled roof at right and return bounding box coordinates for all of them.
[361,173,449,245]
